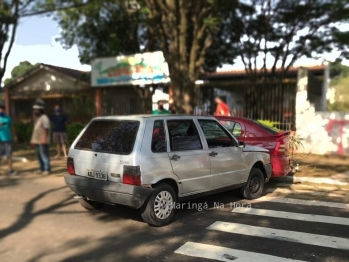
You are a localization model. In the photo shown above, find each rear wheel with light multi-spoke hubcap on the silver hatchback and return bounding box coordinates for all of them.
[141,184,177,227]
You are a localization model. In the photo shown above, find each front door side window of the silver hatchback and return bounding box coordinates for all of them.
[199,120,235,148]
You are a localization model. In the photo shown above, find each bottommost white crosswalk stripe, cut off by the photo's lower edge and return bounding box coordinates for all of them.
[175,242,301,262]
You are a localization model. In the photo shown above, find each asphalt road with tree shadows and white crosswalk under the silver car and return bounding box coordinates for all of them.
[0,173,349,262]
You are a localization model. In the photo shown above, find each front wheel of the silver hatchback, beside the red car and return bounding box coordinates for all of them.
[241,167,264,200]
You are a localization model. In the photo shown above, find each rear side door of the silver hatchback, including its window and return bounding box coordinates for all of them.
[166,119,211,195]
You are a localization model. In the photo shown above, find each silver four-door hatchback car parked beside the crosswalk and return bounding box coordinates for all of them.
[64,115,272,226]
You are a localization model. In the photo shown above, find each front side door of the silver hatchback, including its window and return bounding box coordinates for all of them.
[198,119,246,189]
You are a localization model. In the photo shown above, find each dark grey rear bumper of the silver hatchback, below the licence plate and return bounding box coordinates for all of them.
[64,175,153,209]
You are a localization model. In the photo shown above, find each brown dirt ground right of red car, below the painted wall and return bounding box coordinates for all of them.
[291,153,349,177]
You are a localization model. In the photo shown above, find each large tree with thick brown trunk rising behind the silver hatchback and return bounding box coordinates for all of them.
[51,0,246,113]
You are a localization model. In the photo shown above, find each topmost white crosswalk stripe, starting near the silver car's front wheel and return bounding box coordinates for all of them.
[251,196,349,209]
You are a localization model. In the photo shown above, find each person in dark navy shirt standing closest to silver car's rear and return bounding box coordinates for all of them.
[50,105,67,158]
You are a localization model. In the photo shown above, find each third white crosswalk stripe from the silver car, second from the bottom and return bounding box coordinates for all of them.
[207,221,349,250]
